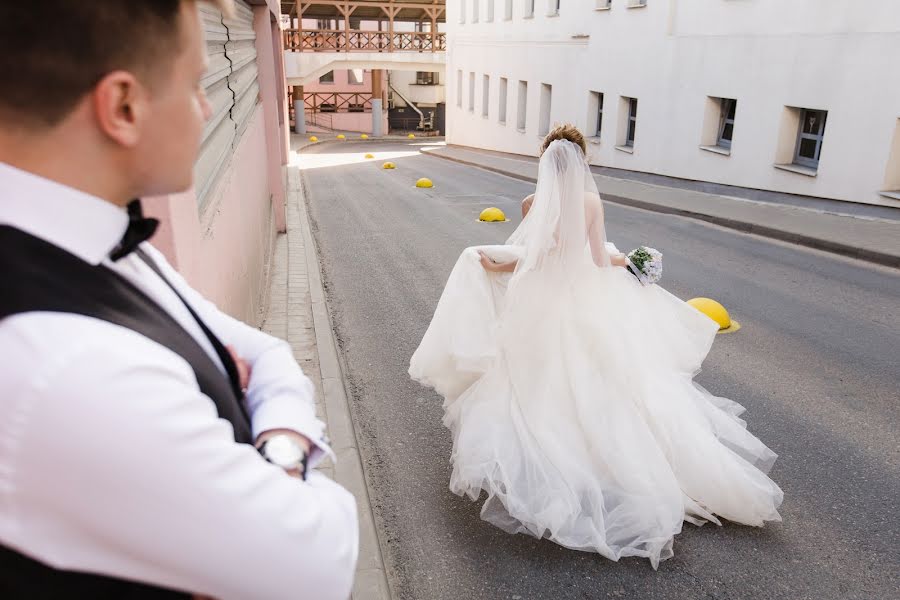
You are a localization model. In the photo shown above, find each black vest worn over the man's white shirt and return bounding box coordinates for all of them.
[0,225,253,600]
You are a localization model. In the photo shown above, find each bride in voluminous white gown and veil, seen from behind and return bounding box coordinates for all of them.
[410,127,783,568]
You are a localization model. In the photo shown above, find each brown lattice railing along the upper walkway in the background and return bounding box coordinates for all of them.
[284,29,447,52]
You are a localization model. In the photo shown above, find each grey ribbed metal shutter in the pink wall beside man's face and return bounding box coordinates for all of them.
[194,0,259,207]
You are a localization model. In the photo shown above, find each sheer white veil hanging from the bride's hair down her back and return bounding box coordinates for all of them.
[507,140,610,276]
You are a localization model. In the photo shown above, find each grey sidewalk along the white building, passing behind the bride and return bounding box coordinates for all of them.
[423,146,900,268]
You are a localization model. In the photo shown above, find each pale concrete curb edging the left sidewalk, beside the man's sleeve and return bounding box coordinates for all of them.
[298,169,392,600]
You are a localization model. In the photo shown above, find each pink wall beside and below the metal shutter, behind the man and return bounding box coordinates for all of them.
[144,0,289,325]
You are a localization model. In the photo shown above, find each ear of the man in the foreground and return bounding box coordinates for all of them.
[91,71,147,148]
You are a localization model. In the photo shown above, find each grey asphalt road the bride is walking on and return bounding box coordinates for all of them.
[302,140,900,600]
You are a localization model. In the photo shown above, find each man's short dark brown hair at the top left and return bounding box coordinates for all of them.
[0,0,233,128]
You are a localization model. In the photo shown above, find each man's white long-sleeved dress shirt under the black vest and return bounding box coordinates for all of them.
[0,163,358,600]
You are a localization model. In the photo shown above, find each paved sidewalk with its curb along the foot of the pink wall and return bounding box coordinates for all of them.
[262,146,391,600]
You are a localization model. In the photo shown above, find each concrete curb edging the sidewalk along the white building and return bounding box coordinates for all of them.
[422,150,900,268]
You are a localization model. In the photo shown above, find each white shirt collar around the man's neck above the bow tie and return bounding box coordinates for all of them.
[0,162,128,265]
